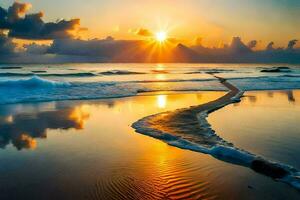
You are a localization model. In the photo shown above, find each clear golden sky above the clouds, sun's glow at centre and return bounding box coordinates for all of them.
[0,0,300,48]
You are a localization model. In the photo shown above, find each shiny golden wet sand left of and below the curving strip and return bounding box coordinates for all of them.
[0,92,299,199]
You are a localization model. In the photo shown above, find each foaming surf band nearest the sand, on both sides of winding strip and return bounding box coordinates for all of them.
[0,72,300,104]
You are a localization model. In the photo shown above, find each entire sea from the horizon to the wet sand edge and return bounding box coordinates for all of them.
[0,64,300,104]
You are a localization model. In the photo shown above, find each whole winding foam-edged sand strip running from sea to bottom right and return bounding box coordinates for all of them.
[132,73,300,190]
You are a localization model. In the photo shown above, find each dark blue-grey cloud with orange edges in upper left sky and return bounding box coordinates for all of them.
[0,2,83,40]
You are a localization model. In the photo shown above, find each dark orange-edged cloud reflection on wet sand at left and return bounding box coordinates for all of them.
[0,105,90,150]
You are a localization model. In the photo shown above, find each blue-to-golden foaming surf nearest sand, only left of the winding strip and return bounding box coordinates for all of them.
[0,76,224,104]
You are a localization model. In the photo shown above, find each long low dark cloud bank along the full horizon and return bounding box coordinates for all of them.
[0,30,300,63]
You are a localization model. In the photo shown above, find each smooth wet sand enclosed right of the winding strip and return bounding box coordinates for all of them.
[208,90,300,169]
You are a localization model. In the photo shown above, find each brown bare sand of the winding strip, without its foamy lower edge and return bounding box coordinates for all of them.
[133,76,243,147]
